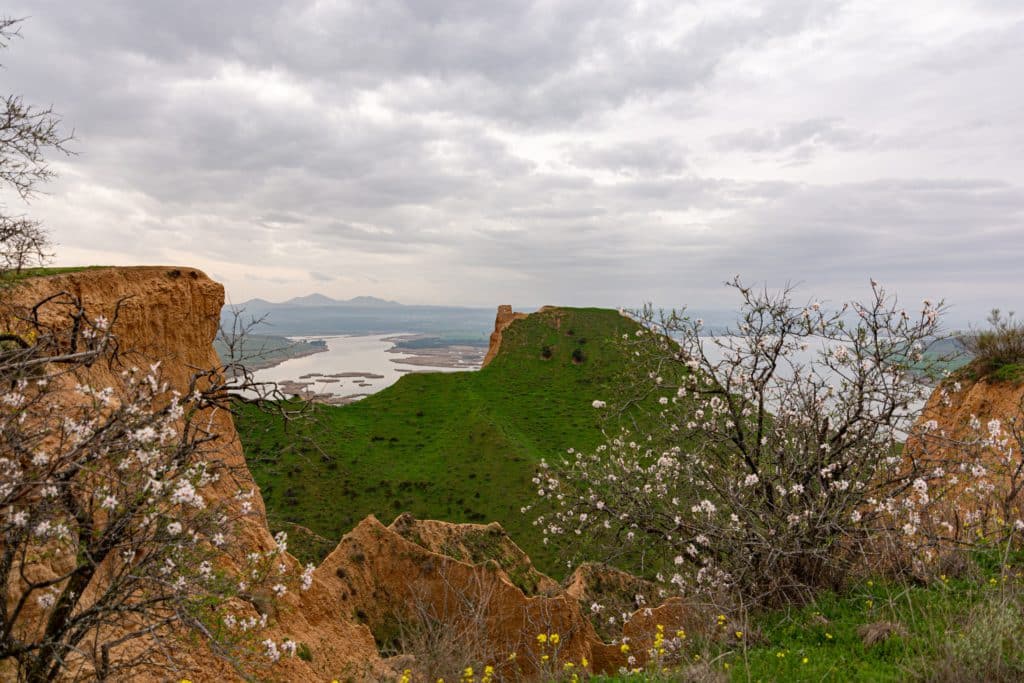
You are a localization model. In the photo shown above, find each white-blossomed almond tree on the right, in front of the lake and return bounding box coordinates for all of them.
[535,279,1007,602]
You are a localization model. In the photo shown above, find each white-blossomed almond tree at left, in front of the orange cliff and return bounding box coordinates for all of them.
[0,293,311,681]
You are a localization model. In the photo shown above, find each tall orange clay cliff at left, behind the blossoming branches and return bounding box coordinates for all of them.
[0,266,383,681]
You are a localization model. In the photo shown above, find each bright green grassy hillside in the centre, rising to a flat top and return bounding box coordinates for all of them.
[237,308,637,573]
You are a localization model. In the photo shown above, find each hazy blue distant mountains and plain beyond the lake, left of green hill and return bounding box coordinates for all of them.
[221,294,497,343]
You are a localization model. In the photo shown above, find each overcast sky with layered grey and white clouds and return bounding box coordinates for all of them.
[0,0,1024,319]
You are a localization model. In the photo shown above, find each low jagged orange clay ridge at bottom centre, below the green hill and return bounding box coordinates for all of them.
[315,514,711,680]
